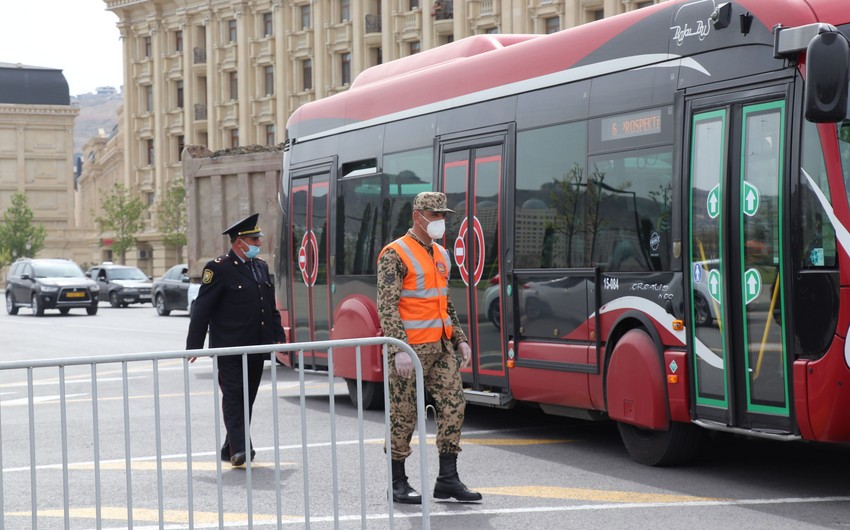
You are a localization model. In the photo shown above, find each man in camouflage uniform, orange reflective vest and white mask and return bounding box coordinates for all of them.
[378,192,481,504]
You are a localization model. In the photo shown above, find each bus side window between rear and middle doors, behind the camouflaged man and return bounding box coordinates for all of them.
[336,148,433,275]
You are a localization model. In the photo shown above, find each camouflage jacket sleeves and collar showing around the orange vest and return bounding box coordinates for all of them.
[378,232,467,354]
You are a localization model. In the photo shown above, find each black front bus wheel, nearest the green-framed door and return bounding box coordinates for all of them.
[617,421,703,467]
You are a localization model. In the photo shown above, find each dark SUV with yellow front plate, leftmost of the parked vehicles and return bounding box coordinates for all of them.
[6,258,100,317]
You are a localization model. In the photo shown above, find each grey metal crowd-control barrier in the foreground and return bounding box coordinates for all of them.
[0,337,430,530]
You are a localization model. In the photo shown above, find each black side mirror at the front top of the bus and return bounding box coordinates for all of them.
[804,32,850,123]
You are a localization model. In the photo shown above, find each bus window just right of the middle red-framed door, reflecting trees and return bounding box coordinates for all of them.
[514,122,588,269]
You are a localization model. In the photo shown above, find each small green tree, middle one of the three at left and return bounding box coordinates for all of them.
[95,183,147,265]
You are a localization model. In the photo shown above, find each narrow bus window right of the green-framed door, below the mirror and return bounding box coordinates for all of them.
[800,121,836,269]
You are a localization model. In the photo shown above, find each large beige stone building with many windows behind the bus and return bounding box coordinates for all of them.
[82,0,663,274]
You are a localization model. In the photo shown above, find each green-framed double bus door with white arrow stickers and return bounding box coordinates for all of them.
[684,87,792,432]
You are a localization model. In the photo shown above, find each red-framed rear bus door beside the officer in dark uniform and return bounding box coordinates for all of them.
[284,164,333,369]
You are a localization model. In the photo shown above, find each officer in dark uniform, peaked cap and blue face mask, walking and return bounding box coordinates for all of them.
[186,213,286,466]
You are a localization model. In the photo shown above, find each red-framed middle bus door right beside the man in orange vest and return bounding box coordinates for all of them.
[439,127,507,391]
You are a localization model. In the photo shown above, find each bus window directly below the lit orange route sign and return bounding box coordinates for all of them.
[584,148,673,272]
